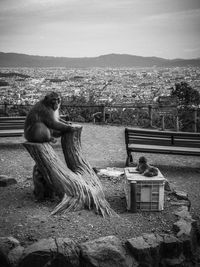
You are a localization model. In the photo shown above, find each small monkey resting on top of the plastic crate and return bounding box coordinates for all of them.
[136,157,158,177]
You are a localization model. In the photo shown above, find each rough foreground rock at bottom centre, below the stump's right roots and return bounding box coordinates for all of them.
[80,236,128,267]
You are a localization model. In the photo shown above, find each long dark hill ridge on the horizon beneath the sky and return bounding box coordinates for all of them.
[0,52,200,68]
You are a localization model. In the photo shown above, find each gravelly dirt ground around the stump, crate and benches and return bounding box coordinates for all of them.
[0,124,200,246]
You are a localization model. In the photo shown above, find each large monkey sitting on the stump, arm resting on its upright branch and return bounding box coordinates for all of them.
[24,92,73,143]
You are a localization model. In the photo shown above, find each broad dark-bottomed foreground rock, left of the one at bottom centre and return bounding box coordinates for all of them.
[18,238,79,267]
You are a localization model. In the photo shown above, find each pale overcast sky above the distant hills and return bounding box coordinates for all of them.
[0,0,200,58]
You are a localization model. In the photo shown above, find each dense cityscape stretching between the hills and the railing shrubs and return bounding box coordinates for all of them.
[0,67,200,105]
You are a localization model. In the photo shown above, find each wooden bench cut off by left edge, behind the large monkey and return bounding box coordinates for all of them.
[0,116,25,137]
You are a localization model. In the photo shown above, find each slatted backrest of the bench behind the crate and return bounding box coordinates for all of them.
[125,128,200,147]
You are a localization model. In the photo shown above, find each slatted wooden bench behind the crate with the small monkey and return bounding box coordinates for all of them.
[125,128,200,166]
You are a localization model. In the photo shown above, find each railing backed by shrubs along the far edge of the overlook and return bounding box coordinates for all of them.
[0,103,200,132]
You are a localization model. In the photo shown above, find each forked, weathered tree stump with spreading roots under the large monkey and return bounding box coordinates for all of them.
[23,126,115,216]
